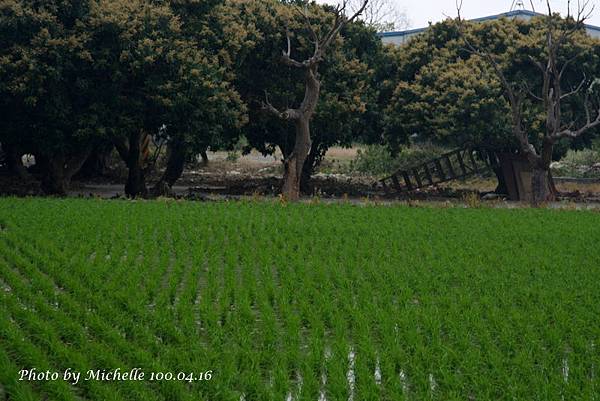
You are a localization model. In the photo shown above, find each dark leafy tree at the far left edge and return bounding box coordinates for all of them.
[0,0,105,194]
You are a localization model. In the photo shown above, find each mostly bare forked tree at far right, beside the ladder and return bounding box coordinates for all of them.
[458,0,600,204]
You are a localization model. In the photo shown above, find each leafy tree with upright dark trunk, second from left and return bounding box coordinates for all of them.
[85,0,183,197]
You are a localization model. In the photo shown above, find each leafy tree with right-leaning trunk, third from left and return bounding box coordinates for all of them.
[153,0,250,195]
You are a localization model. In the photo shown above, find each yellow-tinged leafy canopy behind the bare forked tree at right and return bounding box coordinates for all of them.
[386,17,600,156]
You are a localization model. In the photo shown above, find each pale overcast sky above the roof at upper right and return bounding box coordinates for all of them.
[317,0,600,28]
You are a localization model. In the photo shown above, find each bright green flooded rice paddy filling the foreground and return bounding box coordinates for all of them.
[0,198,600,401]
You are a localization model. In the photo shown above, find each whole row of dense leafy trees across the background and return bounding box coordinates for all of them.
[0,0,600,197]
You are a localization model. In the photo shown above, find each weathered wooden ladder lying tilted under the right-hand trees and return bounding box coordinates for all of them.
[380,147,499,193]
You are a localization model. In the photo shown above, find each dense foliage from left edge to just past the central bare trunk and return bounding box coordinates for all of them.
[0,0,384,196]
